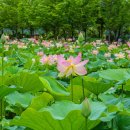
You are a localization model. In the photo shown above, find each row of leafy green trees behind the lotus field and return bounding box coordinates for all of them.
[0,0,130,40]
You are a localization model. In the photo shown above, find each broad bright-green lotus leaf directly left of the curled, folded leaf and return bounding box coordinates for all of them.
[7,71,43,92]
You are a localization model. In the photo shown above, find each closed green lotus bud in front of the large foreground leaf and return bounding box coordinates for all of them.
[82,98,91,117]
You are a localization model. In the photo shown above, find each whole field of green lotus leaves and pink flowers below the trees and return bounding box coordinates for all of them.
[0,35,130,130]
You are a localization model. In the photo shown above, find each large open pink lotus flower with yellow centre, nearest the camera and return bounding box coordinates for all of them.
[57,53,88,77]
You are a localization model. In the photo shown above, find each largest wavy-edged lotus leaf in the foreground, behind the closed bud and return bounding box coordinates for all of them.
[11,101,99,130]
